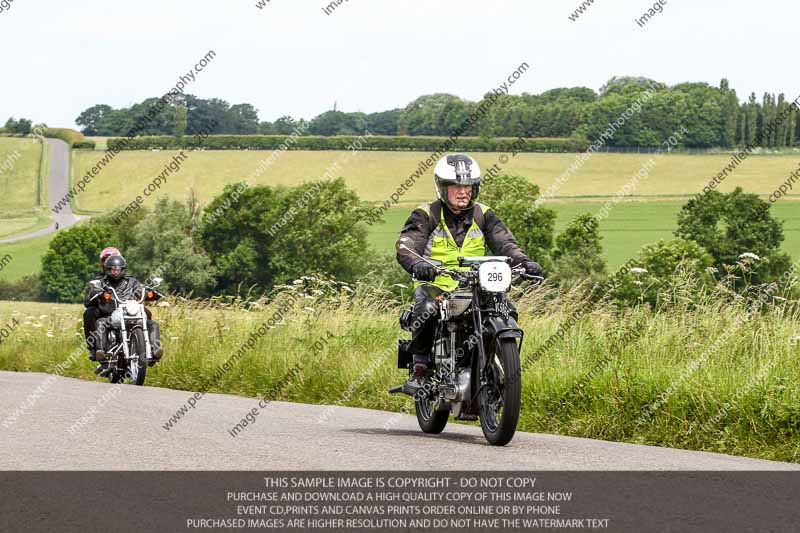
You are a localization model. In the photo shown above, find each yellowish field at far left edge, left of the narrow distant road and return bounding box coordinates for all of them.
[0,137,49,239]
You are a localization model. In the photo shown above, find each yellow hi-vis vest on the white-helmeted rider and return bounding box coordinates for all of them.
[414,203,489,291]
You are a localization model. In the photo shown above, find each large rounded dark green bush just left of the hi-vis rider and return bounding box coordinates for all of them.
[200,178,376,293]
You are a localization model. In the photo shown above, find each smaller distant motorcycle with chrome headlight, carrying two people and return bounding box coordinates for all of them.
[89,278,164,385]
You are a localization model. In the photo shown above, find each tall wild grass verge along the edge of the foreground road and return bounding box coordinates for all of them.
[0,285,800,462]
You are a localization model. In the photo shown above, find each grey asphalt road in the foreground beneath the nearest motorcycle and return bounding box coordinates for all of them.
[0,370,800,471]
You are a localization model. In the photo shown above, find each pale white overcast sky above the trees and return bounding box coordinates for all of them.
[0,0,800,127]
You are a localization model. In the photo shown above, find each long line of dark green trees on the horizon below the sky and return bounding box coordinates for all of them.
[65,77,800,148]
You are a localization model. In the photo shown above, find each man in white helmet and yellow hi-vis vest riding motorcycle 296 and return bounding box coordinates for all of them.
[397,154,542,383]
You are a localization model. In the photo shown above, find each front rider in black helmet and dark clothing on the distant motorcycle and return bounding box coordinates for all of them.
[84,254,164,362]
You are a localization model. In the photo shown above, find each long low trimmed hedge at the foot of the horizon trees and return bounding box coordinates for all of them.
[108,135,589,152]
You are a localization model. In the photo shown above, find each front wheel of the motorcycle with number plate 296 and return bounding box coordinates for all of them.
[480,338,522,446]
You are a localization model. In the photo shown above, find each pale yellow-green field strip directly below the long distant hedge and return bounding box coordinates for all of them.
[73,150,800,212]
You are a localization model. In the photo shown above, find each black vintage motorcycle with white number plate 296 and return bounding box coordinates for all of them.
[389,244,543,446]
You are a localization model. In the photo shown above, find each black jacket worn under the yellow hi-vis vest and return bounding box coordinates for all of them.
[397,200,530,274]
